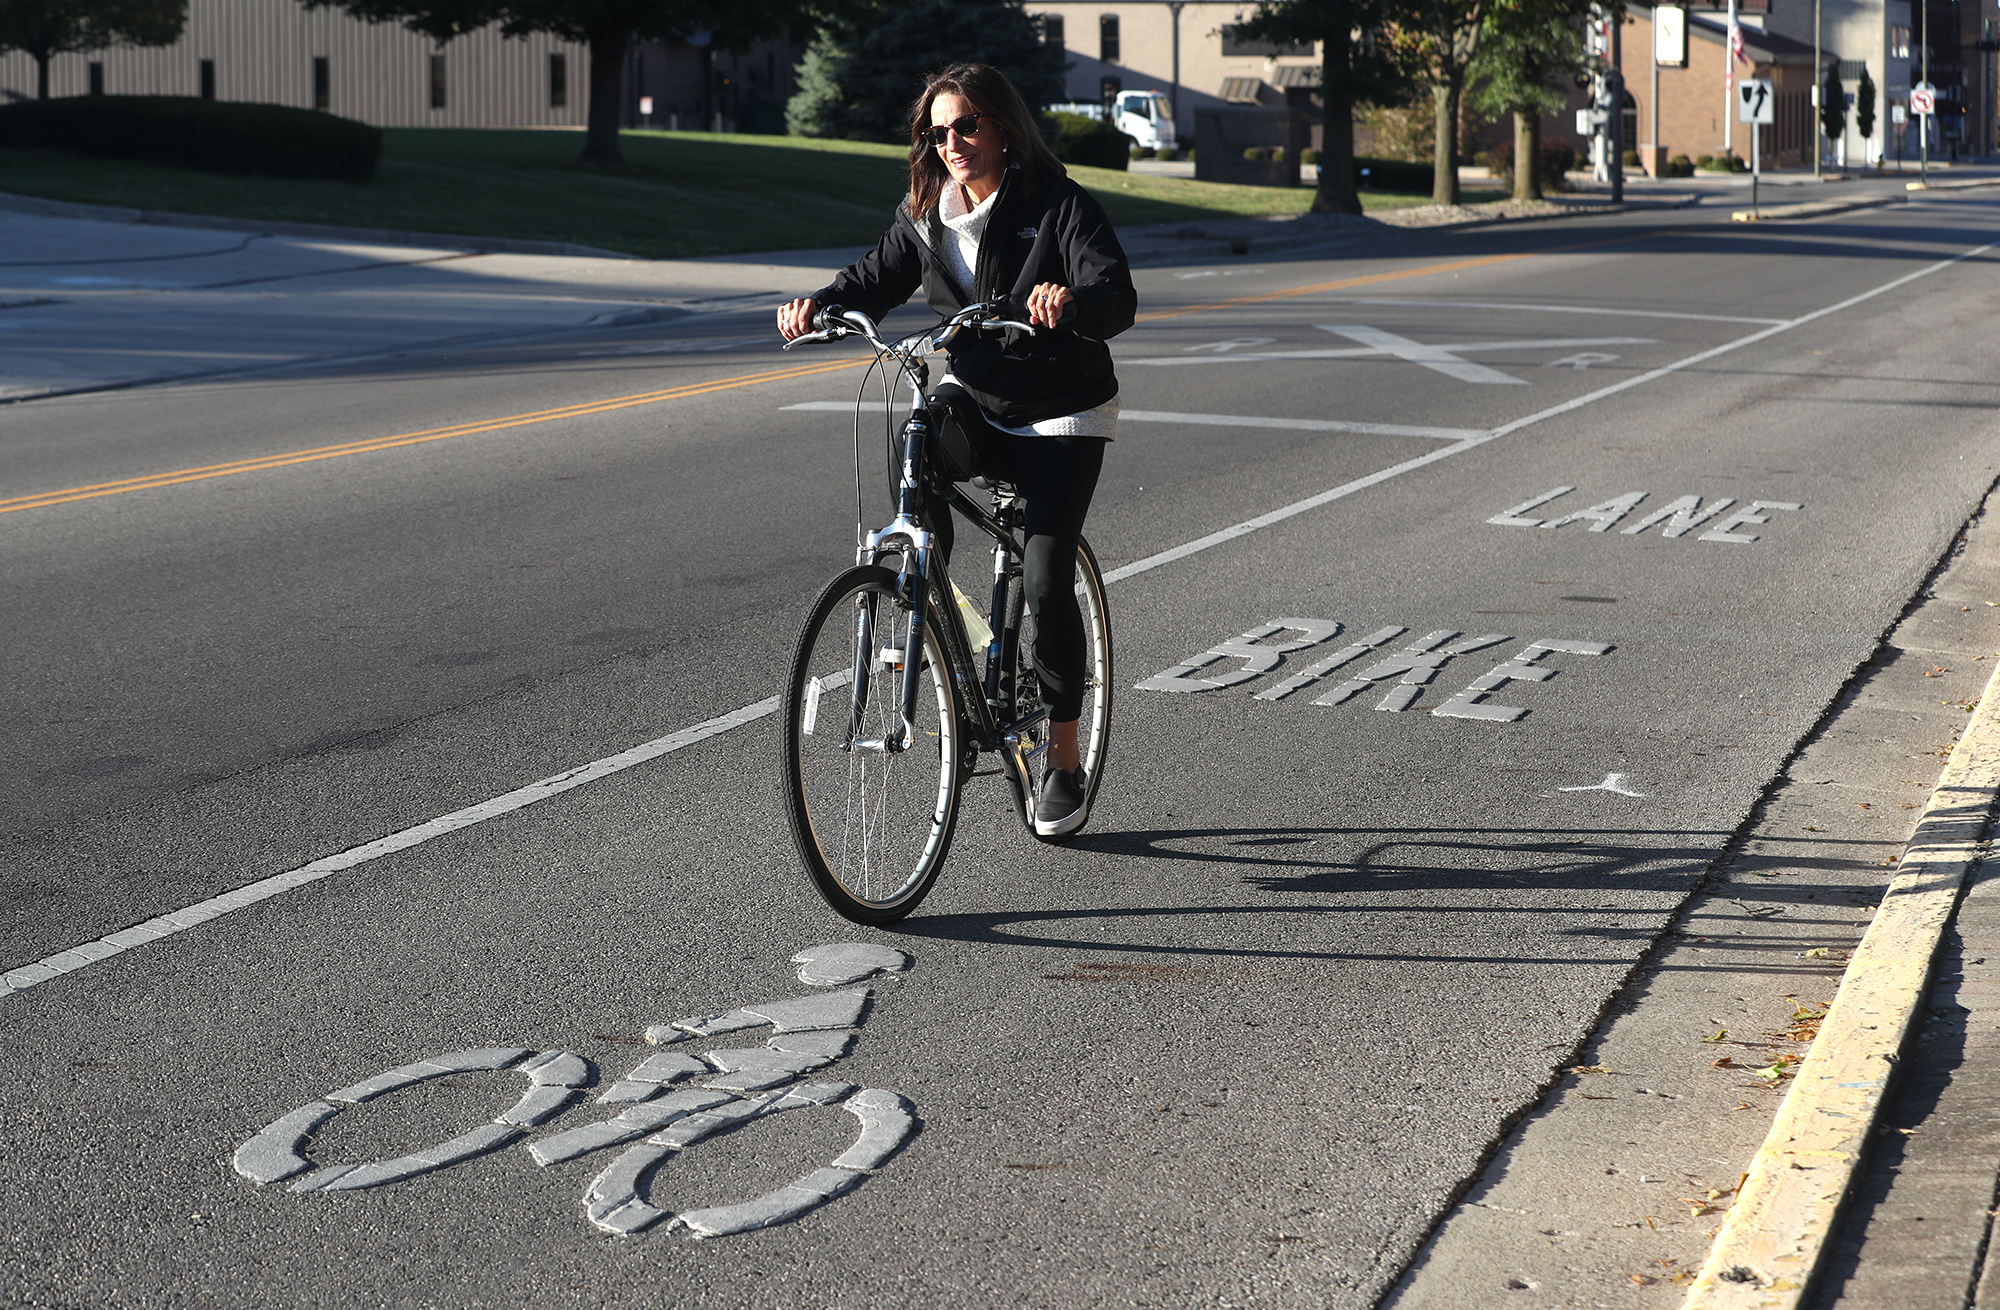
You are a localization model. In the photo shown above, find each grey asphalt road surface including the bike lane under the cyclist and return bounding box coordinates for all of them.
[0,192,2000,1306]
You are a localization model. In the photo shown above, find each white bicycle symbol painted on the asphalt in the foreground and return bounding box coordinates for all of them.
[234,942,918,1238]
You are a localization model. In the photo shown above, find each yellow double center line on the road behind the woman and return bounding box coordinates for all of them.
[0,238,1632,514]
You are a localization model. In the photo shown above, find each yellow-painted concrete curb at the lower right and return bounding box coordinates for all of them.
[1682,652,2000,1310]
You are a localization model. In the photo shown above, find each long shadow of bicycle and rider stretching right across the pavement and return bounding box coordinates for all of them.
[890,826,1880,976]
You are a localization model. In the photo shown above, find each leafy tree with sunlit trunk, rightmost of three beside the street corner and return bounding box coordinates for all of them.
[1472,0,1590,200]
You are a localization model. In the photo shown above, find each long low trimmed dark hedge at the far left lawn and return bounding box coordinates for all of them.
[0,96,382,182]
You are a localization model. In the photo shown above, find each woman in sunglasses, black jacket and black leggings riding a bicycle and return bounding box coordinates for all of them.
[778,64,1138,836]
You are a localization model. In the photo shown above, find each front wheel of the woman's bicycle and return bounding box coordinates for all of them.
[784,566,966,926]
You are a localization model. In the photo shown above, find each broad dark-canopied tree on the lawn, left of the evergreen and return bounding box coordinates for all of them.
[296,0,844,164]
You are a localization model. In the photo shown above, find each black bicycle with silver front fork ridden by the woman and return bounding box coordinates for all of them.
[784,302,1112,926]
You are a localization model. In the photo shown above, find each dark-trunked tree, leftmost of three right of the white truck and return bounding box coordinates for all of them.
[1236,0,1404,214]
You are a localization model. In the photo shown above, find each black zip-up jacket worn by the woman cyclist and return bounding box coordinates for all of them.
[812,166,1138,428]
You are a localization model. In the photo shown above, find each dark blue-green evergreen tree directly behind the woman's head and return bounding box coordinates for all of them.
[784,0,1066,142]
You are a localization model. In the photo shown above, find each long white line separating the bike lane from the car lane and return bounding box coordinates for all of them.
[11,242,2000,1000]
